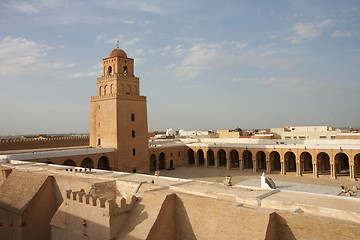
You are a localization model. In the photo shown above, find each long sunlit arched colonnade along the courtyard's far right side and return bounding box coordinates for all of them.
[180,148,360,180]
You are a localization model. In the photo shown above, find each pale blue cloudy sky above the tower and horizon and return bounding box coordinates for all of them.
[0,0,360,135]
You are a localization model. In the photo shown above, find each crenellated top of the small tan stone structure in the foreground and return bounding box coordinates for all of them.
[66,190,137,216]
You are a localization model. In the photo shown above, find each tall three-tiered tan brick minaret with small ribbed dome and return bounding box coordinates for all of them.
[90,46,149,173]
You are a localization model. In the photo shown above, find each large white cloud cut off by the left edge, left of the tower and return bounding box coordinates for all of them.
[0,36,71,76]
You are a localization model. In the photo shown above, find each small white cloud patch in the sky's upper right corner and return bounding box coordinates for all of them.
[287,19,332,44]
